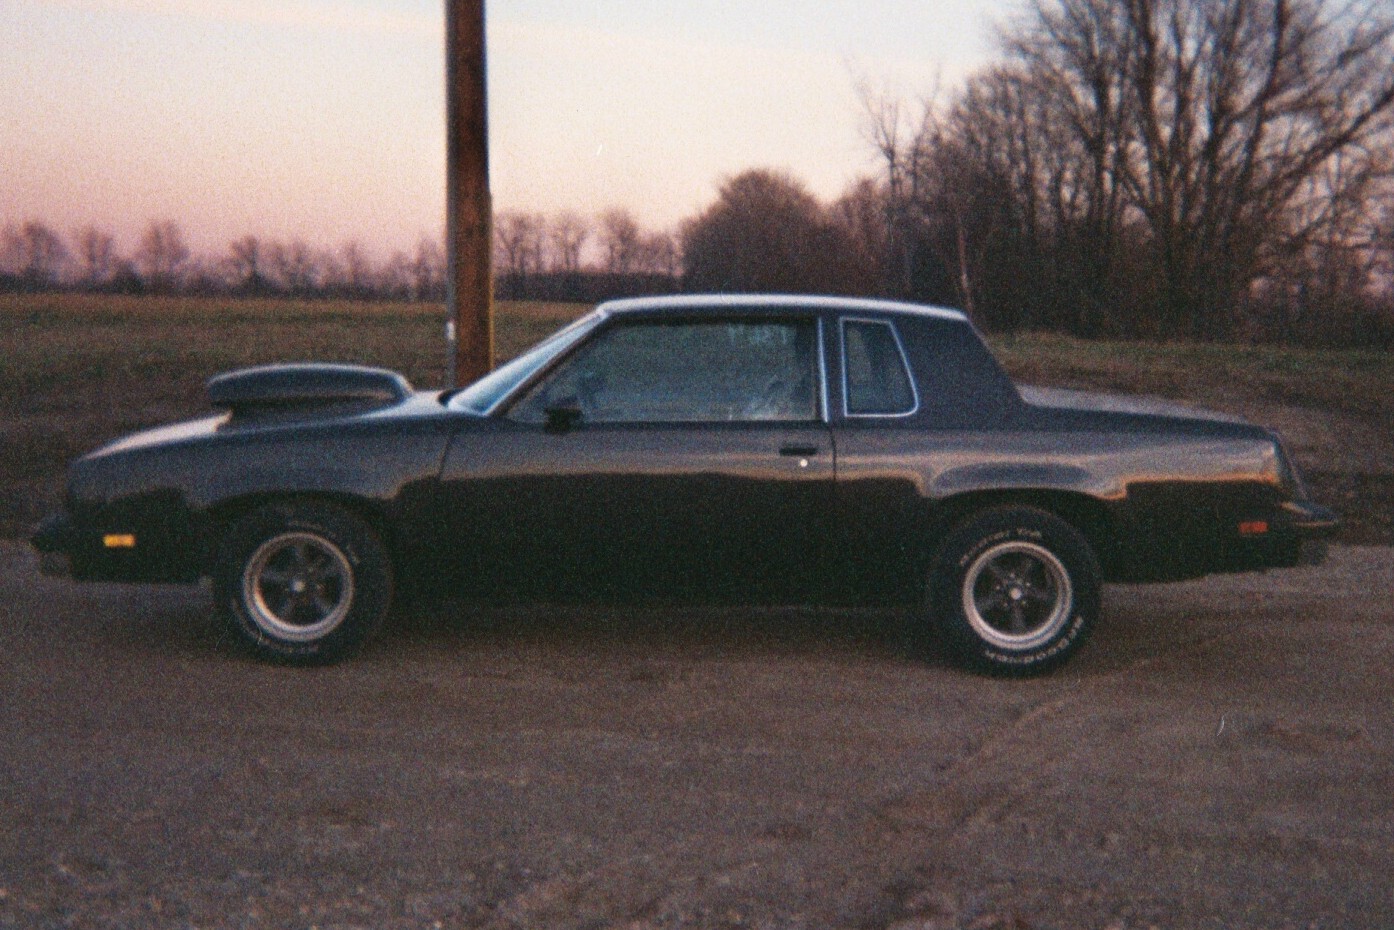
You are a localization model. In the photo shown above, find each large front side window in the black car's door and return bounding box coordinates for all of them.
[510,321,820,422]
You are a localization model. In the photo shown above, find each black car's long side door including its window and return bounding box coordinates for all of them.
[442,317,834,600]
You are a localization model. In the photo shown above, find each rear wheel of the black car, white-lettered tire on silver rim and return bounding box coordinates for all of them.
[926,508,1100,675]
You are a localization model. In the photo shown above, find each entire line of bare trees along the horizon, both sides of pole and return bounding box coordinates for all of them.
[0,0,1394,347]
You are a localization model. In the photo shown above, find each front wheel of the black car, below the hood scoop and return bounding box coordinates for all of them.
[213,502,392,665]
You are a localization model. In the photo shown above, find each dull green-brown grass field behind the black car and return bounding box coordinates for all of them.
[0,294,1394,544]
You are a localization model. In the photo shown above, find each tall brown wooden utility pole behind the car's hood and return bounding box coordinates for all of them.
[445,0,493,388]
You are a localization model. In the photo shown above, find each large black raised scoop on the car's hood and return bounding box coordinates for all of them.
[208,363,413,418]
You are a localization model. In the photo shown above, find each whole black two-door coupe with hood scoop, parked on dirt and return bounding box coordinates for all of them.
[33,296,1337,672]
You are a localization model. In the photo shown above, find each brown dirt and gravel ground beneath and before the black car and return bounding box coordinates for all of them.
[0,542,1394,930]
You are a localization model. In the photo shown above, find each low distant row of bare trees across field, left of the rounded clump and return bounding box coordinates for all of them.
[0,209,680,301]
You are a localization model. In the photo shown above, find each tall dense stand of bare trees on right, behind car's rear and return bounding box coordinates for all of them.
[866,0,1394,346]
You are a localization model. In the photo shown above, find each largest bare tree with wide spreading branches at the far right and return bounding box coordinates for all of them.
[1016,0,1394,336]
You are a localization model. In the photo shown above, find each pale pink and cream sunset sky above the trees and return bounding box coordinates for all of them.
[0,0,1012,251]
